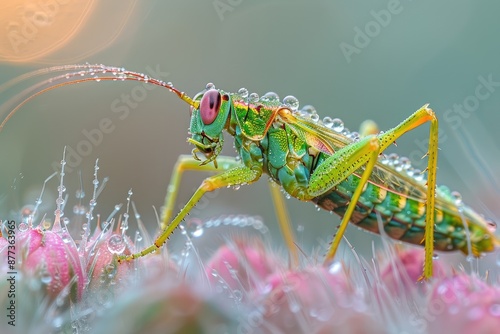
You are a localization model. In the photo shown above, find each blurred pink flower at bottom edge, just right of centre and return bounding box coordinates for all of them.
[245,264,383,333]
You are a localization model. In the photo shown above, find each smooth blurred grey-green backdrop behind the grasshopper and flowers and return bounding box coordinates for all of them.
[0,0,500,258]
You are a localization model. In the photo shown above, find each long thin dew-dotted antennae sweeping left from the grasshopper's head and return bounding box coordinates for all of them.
[0,64,199,131]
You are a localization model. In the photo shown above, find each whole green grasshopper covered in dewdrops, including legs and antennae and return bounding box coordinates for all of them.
[0,65,500,279]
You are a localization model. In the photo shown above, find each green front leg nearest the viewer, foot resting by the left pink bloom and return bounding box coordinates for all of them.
[118,165,262,262]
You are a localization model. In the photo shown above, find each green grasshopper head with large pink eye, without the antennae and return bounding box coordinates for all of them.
[188,85,231,166]
